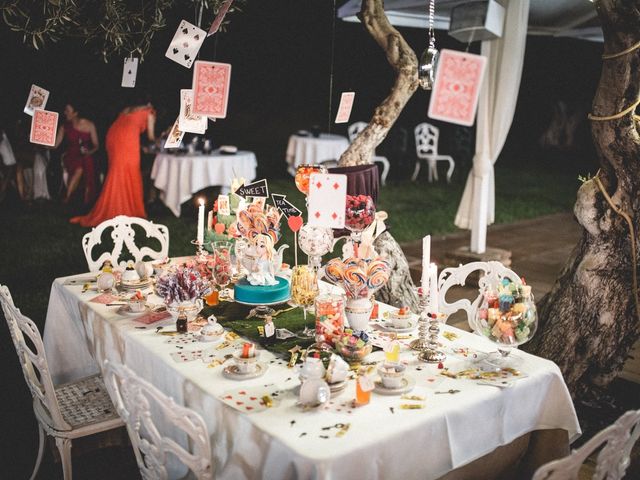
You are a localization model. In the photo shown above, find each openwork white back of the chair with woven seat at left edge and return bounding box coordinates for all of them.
[0,285,71,430]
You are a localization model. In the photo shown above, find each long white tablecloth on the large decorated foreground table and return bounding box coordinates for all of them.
[44,279,580,480]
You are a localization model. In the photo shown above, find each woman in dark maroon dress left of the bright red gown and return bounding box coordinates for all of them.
[54,103,100,206]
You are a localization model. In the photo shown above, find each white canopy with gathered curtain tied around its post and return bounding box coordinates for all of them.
[338,0,602,254]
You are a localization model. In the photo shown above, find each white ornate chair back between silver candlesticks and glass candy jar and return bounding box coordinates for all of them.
[438,261,522,331]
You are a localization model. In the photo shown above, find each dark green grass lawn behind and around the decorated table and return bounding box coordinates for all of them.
[0,165,578,328]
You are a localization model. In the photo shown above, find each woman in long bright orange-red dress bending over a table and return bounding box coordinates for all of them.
[71,104,156,227]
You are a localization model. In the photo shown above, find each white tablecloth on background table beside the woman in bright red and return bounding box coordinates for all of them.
[151,150,258,217]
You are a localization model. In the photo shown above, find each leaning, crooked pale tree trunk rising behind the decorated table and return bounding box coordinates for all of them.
[338,0,418,311]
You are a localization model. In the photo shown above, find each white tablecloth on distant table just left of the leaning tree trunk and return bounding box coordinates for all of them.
[287,133,349,175]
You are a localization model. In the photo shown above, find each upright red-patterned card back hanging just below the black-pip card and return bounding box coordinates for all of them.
[193,60,231,118]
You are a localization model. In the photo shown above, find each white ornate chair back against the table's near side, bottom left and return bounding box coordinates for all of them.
[104,360,213,480]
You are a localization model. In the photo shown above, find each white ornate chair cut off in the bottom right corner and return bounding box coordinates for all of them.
[533,410,640,480]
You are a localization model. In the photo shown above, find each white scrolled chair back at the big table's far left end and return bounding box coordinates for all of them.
[82,215,169,272]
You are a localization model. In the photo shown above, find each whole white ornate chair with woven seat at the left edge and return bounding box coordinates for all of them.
[0,285,124,480]
